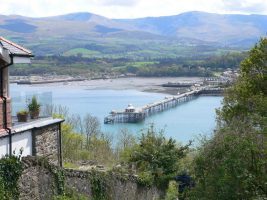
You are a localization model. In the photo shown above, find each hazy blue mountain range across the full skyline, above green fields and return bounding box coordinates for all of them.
[0,12,267,54]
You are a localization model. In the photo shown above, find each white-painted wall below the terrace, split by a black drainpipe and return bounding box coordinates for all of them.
[0,131,32,157]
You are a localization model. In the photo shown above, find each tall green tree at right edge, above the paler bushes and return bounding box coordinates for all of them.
[219,38,267,131]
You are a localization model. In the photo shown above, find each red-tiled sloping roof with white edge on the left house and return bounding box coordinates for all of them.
[0,37,33,57]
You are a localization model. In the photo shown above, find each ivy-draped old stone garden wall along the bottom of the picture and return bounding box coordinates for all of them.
[19,157,162,200]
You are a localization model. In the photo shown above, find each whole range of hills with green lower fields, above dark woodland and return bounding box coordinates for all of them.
[0,12,267,58]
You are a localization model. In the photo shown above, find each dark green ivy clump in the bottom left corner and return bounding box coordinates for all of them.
[0,155,23,200]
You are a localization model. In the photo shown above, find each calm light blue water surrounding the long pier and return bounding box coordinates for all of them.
[10,84,222,143]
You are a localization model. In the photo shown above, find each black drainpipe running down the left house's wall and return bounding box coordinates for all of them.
[0,54,14,156]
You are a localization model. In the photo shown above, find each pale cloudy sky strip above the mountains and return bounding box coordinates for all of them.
[0,0,267,18]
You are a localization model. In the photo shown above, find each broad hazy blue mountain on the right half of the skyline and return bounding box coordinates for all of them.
[117,12,267,45]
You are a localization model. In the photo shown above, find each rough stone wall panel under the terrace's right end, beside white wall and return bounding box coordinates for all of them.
[32,124,61,165]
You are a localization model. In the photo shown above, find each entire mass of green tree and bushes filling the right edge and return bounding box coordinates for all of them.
[189,38,267,200]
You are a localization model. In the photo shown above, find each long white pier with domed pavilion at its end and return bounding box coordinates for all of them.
[104,87,223,124]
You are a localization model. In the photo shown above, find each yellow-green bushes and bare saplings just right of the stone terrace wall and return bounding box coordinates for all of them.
[59,114,115,165]
